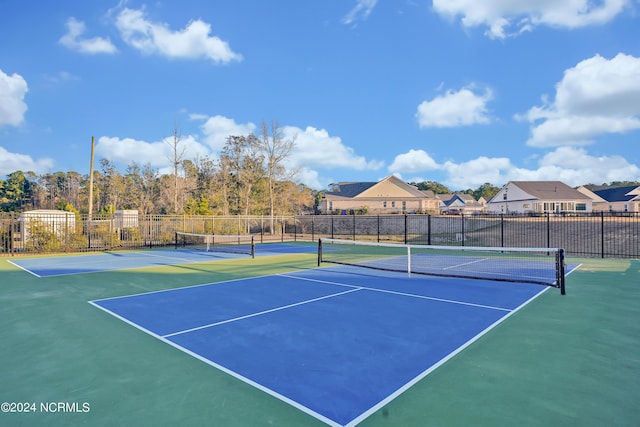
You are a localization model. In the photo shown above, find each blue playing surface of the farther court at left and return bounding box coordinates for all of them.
[9,243,317,277]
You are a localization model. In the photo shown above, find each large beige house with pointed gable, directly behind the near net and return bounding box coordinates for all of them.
[319,175,440,215]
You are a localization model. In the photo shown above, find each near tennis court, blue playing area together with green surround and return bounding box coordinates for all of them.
[0,241,640,426]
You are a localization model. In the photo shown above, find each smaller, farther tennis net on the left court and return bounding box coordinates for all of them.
[175,231,255,258]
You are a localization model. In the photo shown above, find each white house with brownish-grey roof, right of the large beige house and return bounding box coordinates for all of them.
[487,181,592,214]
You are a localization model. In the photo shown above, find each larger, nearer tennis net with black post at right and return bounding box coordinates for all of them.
[318,239,565,295]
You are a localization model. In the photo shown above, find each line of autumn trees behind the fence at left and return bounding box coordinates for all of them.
[0,122,318,217]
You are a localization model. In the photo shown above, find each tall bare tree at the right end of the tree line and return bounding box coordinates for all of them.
[260,120,297,234]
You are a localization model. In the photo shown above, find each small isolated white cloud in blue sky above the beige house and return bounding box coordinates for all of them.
[416,88,493,127]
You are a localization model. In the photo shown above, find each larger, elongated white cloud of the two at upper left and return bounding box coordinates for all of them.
[116,8,242,64]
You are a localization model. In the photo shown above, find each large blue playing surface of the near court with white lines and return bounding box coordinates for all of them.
[91,266,564,426]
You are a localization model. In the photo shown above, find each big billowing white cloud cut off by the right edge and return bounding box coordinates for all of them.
[517,54,640,147]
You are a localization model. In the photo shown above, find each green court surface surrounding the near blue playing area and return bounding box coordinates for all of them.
[0,254,640,427]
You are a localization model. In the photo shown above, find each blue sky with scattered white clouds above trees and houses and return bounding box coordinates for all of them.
[0,0,640,190]
